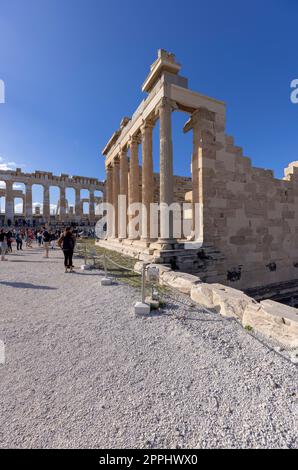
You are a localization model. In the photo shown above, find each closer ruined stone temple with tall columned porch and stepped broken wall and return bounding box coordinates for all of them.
[99,50,298,288]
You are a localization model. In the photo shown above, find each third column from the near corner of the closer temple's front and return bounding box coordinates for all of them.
[128,136,141,238]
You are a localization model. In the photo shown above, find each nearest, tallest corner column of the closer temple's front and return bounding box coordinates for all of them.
[158,98,173,242]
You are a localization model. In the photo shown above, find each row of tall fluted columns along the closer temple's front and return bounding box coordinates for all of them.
[106,98,174,243]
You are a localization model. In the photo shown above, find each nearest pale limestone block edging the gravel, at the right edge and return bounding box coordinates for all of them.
[242,300,298,348]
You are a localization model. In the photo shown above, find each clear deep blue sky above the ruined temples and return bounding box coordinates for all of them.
[0,0,298,191]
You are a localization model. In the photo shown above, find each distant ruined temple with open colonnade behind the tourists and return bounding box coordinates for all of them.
[0,168,105,226]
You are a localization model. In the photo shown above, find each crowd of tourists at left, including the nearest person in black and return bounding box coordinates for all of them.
[0,227,79,272]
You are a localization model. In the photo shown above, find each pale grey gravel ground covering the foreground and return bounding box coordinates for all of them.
[0,248,298,448]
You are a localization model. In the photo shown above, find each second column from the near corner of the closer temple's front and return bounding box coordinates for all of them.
[141,120,154,242]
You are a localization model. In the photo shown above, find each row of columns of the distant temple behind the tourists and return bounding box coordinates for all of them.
[1,180,95,220]
